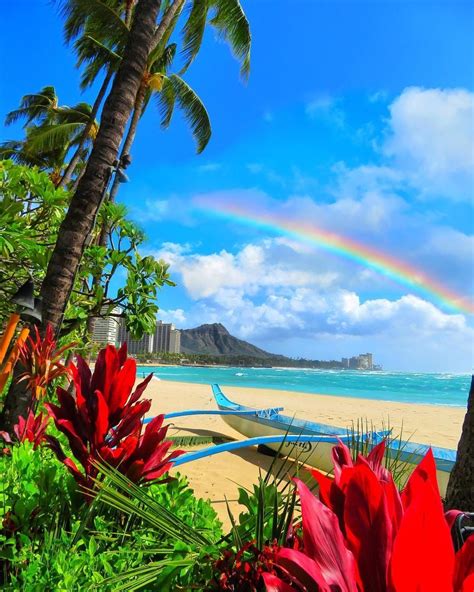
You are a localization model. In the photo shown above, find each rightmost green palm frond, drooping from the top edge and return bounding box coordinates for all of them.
[210,0,252,77]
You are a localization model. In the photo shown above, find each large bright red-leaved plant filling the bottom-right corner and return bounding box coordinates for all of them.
[262,442,474,592]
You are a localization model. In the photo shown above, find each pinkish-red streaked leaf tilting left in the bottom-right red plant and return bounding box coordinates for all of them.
[295,479,357,592]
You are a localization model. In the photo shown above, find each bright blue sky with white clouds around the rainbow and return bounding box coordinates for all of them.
[0,0,474,372]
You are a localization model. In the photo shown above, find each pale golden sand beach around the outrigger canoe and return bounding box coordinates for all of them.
[145,379,465,525]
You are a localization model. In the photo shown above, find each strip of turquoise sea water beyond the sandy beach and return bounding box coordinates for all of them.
[138,366,471,407]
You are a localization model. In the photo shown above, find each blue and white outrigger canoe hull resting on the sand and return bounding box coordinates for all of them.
[210,384,456,497]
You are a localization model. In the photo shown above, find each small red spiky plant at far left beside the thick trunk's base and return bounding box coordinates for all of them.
[18,325,75,399]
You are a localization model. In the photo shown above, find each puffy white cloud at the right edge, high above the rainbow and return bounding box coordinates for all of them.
[383,87,474,200]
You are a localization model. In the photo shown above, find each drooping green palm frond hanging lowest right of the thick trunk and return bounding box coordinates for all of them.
[158,74,212,154]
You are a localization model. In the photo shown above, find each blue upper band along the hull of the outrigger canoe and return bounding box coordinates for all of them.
[212,384,456,473]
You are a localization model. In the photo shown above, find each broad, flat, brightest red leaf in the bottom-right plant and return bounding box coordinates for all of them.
[390,471,454,592]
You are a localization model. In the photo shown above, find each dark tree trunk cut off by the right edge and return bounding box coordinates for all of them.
[445,376,474,512]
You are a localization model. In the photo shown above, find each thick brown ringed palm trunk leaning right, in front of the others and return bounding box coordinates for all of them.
[41,0,160,331]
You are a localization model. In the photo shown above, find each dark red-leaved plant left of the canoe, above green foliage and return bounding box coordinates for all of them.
[46,344,183,490]
